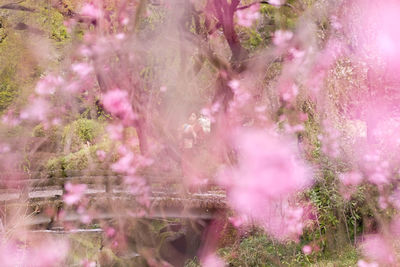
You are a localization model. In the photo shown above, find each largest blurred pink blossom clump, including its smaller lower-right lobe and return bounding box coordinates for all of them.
[219,130,311,239]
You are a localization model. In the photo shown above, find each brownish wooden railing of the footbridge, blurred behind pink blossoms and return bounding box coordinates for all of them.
[0,172,226,229]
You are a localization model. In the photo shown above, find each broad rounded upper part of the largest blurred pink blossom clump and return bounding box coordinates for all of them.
[222,131,311,198]
